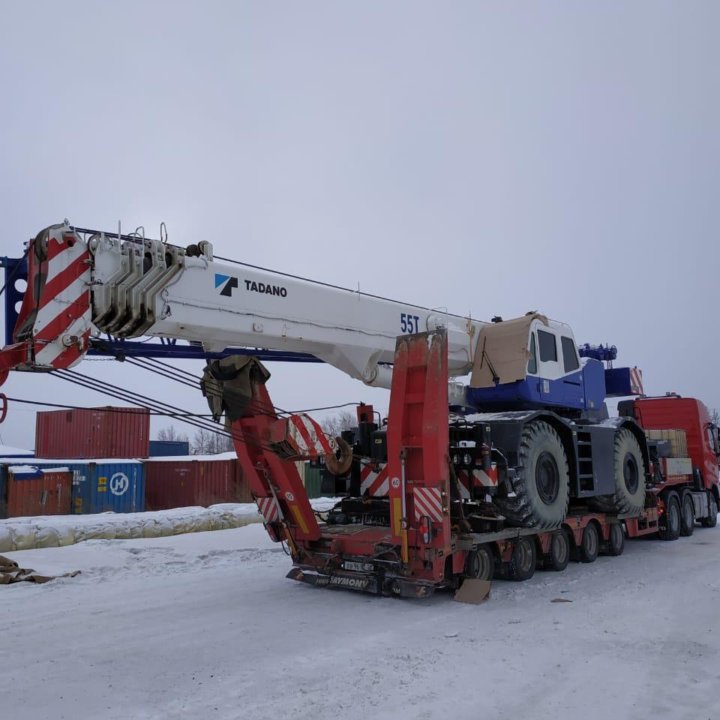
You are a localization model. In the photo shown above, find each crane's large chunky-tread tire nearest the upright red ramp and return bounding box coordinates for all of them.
[495,420,570,530]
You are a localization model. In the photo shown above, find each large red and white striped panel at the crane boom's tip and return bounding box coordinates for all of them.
[33,228,92,368]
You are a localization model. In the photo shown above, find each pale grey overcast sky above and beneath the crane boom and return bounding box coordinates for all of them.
[0,0,720,447]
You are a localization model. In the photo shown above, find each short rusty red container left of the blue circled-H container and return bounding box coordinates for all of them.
[7,466,73,517]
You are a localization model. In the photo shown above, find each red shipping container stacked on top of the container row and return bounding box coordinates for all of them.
[35,407,150,459]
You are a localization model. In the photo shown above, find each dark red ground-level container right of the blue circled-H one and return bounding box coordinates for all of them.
[144,453,252,510]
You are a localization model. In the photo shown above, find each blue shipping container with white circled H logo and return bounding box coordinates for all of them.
[14,458,145,515]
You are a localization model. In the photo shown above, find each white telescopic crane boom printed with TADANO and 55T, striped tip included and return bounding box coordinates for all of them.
[4,224,485,387]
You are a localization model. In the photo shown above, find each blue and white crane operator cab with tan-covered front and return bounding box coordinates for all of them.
[466,313,606,413]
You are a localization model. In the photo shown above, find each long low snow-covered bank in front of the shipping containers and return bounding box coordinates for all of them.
[0,498,336,553]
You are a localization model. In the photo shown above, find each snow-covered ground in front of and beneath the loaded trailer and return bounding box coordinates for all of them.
[0,524,720,720]
